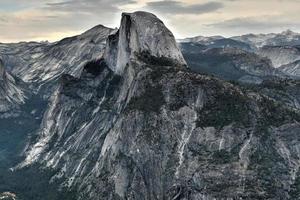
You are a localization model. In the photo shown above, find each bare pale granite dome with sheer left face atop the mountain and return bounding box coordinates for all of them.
[104,12,186,74]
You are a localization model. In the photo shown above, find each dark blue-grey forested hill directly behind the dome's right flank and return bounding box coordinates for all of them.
[180,43,283,83]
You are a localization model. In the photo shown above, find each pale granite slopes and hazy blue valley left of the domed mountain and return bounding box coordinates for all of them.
[0,25,114,200]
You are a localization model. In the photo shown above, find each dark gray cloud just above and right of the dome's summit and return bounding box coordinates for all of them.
[147,0,224,14]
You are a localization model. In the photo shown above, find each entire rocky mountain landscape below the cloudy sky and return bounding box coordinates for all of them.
[0,9,300,200]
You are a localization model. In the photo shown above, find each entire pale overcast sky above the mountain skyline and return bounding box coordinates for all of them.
[0,0,300,42]
